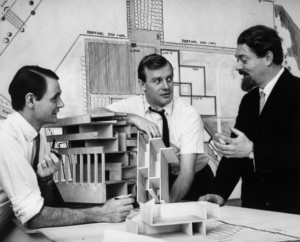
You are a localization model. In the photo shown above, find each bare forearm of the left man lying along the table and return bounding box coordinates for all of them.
[28,206,102,229]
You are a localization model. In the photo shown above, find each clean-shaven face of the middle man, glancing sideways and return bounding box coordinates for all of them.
[141,63,173,109]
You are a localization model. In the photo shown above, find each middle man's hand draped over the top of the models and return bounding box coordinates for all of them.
[128,114,161,138]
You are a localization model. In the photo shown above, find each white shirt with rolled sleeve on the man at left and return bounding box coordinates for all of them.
[0,112,45,224]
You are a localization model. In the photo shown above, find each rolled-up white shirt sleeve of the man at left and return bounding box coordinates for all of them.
[0,139,44,224]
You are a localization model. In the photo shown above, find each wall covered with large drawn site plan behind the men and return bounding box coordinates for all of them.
[0,0,300,164]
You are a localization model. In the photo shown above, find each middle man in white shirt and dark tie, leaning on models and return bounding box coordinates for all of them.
[103,54,213,202]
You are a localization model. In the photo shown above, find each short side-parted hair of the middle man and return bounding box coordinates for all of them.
[138,54,173,82]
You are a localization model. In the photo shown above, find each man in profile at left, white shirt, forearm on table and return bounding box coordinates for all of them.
[0,66,133,235]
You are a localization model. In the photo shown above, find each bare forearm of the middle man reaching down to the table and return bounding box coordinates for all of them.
[170,172,195,202]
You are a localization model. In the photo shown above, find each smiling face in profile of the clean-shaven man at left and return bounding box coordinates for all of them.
[34,77,64,125]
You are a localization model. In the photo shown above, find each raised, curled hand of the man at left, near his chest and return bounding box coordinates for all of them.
[37,152,59,177]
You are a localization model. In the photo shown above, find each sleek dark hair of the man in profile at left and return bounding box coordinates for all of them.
[8,66,59,111]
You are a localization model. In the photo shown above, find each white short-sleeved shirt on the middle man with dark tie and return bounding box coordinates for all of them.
[106,95,204,172]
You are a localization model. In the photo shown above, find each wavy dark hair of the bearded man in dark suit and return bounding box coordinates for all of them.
[237,25,283,65]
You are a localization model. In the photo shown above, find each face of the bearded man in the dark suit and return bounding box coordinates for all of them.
[236,44,267,87]
